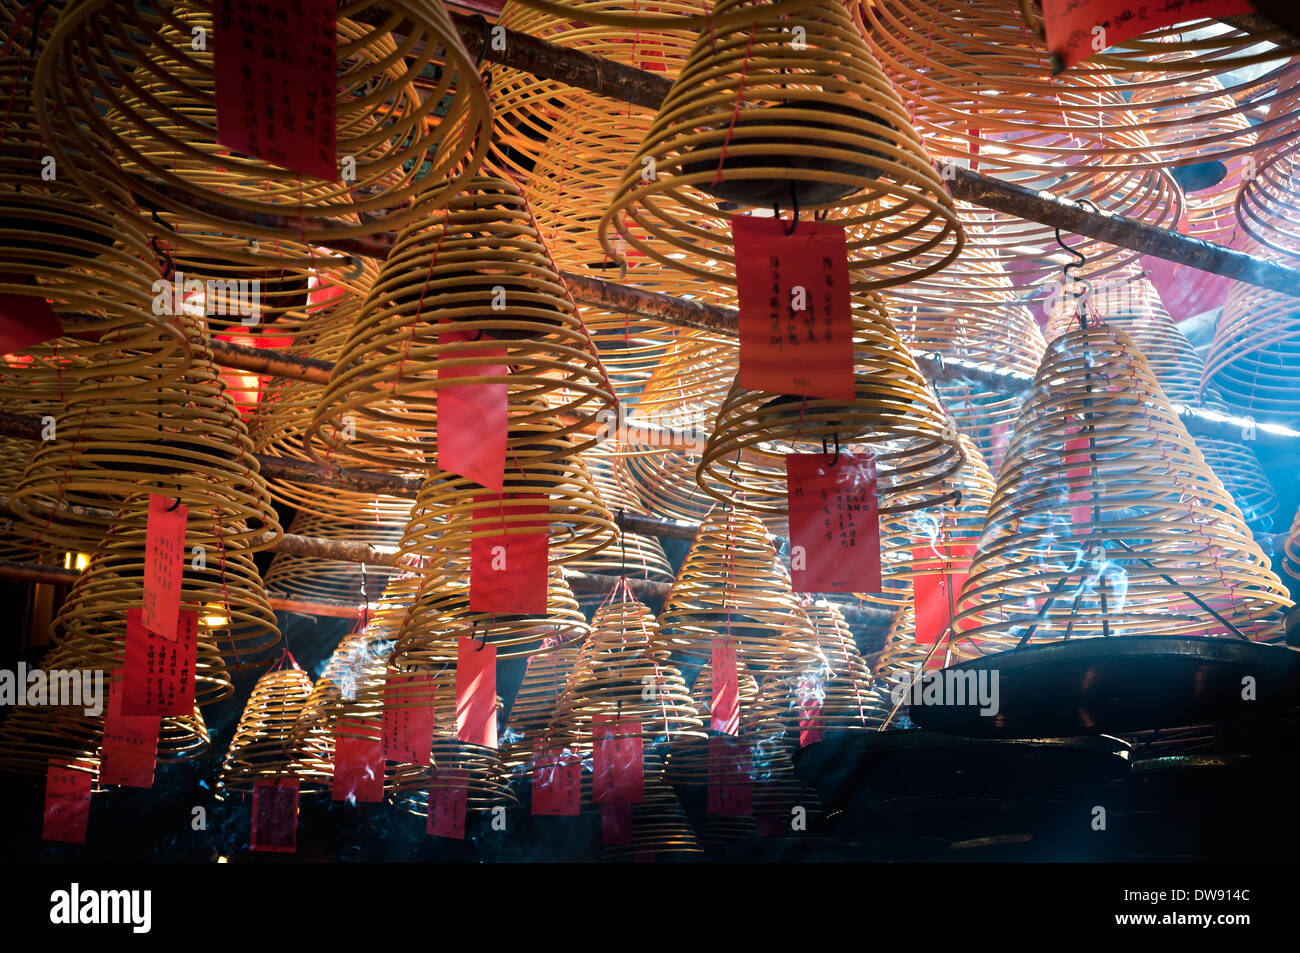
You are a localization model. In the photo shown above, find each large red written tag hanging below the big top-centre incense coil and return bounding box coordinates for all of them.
[732,216,855,400]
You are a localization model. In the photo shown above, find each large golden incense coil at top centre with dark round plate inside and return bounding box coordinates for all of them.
[601,0,961,287]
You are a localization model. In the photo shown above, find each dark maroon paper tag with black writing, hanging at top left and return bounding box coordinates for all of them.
[212,0,339,182]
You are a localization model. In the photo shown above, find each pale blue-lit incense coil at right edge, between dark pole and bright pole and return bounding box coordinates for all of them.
[1201,263,1300,424]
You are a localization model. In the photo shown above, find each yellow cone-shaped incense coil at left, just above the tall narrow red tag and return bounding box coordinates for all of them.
[9,317,281,553]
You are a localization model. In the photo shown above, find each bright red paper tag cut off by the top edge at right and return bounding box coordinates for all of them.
[1043,0,1255,69]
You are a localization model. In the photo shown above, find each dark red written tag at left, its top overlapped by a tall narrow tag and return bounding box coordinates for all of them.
[122,608,199,715]
